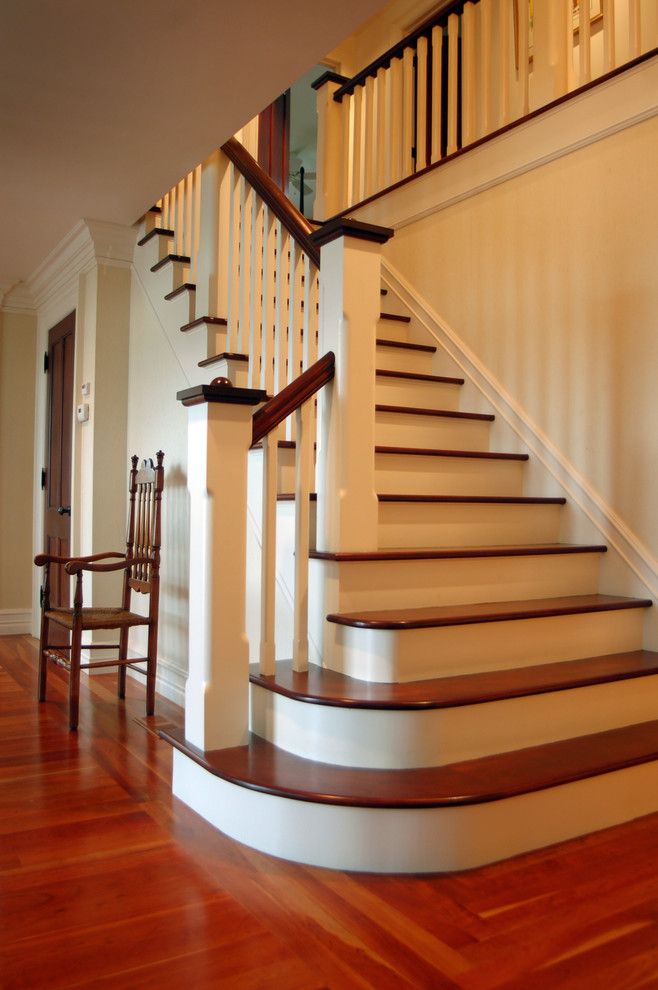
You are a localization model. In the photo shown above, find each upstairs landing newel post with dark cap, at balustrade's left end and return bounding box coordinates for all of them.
[313,72,347,220]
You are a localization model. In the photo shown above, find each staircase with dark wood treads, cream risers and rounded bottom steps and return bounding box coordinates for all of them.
[136,186,658,872]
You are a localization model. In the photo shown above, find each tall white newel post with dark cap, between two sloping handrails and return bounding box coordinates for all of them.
[312,218,393,552]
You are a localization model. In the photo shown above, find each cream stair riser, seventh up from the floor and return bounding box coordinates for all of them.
[375,410,491,450]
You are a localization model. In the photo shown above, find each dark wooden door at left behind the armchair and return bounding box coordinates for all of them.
[44,313,75,620]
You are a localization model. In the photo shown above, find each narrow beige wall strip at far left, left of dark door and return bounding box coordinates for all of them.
[0,310,36,611]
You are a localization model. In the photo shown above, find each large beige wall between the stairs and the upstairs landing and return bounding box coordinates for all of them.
[386,118,658,557]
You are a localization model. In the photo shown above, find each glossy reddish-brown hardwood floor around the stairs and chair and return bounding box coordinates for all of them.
[0,637,658,990]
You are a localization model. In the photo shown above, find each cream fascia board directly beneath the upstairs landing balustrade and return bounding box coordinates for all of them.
[348,56,658,230]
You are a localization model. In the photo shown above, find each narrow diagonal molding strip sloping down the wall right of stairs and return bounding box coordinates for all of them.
[382,259,658,598]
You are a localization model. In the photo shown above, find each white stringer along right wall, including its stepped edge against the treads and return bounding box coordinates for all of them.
[382,258,658,649]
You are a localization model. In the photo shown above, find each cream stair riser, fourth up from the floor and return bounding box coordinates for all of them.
[310,553,600,623]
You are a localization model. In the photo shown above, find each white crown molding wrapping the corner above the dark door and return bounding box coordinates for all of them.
[26,220,136,309]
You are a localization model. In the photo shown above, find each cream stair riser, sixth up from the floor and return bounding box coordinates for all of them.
[375,454,525,504]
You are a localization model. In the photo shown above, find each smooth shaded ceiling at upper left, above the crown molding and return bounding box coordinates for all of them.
[0,0,382,294]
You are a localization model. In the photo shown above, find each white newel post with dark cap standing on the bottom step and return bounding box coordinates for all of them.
[177,384,265,750]
